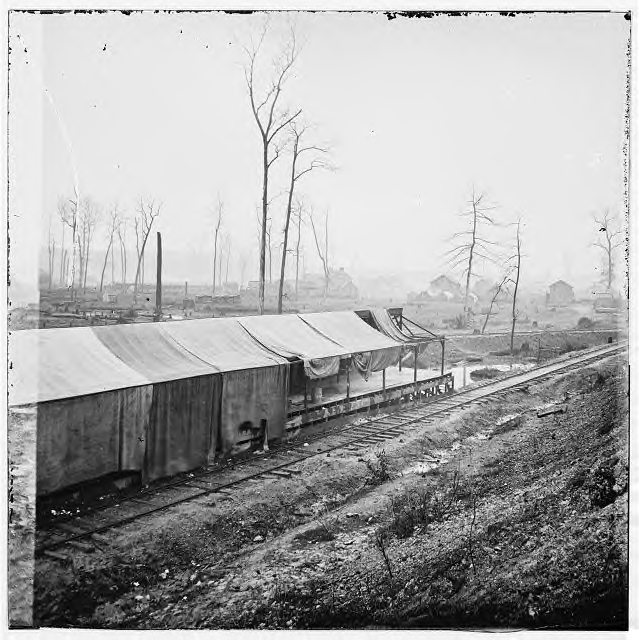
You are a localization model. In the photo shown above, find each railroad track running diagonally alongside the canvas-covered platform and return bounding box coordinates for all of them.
[35,343,627,560]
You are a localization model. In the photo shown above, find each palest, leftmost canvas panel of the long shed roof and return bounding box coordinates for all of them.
[9,327,150,406]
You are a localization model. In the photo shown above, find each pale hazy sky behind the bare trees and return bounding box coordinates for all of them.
[9,12,630,298]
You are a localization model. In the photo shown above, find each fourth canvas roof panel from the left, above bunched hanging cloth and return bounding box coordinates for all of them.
[239,314,350,362]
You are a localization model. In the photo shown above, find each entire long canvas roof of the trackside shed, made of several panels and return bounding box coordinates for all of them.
[9,312,398,406]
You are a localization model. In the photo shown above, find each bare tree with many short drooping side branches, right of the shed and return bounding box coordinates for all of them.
[445,187,497,318]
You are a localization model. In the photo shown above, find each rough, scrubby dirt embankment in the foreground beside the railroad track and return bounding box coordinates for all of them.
[35,358,628,629]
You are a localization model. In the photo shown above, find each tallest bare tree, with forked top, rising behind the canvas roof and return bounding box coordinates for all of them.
[244,23,301,314]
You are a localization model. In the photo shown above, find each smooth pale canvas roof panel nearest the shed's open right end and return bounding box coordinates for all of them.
[300,311,401,353]
